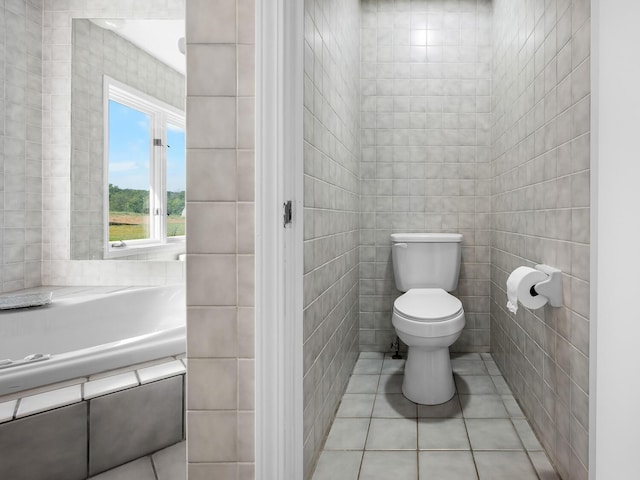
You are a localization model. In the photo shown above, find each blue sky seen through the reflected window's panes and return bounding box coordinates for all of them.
[109,101,185,192]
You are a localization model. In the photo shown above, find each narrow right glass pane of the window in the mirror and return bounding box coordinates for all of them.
[167,124,186,237]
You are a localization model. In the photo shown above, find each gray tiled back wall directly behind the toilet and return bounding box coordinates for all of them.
[360,0,492,352]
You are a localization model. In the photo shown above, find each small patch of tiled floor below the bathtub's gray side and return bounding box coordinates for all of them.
[89,442,187,480]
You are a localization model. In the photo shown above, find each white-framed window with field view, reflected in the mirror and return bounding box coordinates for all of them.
[105,77,186,256]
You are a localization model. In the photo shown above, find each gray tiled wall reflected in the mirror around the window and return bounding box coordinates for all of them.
[71,19,185,260]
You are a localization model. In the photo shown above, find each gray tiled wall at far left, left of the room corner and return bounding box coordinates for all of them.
[0,0,42,292]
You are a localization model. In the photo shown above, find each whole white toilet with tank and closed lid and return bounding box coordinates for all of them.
[391,233,465,405]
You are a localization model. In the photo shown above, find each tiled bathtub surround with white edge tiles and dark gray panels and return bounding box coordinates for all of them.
[0,358,186,480]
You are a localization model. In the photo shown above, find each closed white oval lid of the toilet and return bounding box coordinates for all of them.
[393,288,462,322]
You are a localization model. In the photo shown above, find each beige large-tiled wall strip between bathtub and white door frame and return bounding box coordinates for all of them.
[186,0,255,474]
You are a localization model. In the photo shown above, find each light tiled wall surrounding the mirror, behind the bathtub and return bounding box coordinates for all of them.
[41,0,184,285]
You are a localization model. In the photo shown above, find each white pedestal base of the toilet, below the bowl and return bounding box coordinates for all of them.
[402,346,456,405]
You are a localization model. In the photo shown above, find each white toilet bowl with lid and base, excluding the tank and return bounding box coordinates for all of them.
[392,288,465,405]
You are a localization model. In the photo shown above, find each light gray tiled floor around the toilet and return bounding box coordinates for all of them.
[313,352,558,480]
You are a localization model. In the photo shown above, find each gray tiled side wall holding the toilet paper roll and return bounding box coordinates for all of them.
[491,0,590,480]
